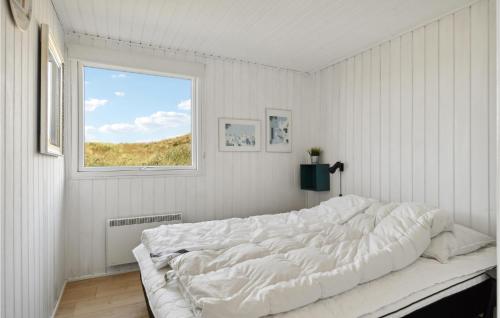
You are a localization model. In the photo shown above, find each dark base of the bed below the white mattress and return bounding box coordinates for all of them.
[141,268,496,318]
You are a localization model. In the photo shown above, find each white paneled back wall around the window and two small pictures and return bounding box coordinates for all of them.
[66,35,314,277]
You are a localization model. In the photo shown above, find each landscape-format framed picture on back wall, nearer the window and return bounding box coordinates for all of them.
[219,118,260,151]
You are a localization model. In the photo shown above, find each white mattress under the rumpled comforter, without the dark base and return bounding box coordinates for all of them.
[133,245,496,318]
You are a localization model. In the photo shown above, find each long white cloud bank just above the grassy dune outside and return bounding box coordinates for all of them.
[99,111,191,133]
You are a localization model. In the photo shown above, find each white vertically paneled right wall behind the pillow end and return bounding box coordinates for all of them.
[314,0,496,234]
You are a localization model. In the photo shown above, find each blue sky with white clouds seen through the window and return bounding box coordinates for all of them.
[84,67,191,143]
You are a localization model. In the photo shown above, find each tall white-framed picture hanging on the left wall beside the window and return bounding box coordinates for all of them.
[39,24,63,156]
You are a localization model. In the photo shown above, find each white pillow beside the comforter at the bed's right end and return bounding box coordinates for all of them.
[422,224,495,263]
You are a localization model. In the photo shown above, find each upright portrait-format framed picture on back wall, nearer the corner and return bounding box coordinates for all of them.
[266,108,292,152]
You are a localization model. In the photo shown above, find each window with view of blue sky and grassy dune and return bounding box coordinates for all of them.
[79,64,197,171]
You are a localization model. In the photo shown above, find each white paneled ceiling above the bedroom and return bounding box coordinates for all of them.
[52,0,471,71]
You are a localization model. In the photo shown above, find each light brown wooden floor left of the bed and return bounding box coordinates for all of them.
[55,272,148,318]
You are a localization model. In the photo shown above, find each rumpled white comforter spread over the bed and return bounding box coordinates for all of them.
[142,196,452,317]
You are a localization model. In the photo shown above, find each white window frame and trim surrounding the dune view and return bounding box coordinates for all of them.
[70,50,202,178]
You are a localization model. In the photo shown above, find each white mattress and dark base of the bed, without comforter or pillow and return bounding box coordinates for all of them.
[133,195,496,318]
